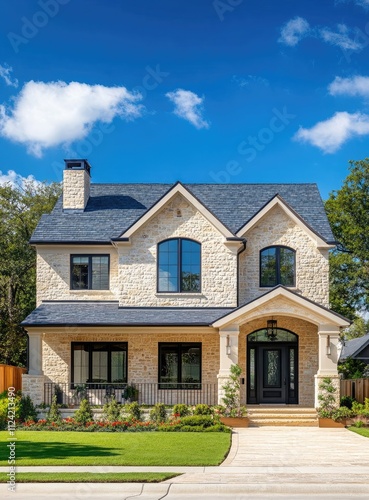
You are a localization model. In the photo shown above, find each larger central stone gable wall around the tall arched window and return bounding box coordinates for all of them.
[119,195,237,307]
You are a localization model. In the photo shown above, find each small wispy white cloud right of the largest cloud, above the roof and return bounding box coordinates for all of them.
[165,89,209,128]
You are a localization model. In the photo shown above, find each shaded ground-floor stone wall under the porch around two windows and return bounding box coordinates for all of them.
[42,327,219,385]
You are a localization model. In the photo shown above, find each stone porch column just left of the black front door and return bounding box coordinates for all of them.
[218,326,240,404]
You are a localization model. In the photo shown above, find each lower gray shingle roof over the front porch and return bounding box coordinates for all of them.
[21,301,232,326]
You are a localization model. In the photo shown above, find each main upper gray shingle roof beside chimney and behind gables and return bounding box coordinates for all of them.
[31,184,334,244]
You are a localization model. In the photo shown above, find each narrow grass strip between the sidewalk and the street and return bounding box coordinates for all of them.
[0,472,180,483]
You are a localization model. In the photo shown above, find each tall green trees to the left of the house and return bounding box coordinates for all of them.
[0,181,61,366]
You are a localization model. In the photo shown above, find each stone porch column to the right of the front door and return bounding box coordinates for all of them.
[315,325,340,408]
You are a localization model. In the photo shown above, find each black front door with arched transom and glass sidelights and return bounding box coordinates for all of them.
[246,328,298,404]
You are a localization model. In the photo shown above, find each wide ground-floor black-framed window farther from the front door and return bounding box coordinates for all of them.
[72,342,127,384]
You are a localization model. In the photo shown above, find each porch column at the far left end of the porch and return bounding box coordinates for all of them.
[22,332,45,405]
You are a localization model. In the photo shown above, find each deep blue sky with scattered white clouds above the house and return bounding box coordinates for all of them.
[0,0,369,198]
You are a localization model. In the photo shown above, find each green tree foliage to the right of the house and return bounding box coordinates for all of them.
[325,158,369,319]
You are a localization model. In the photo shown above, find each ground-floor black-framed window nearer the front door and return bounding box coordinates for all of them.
[159,342,201,389]
